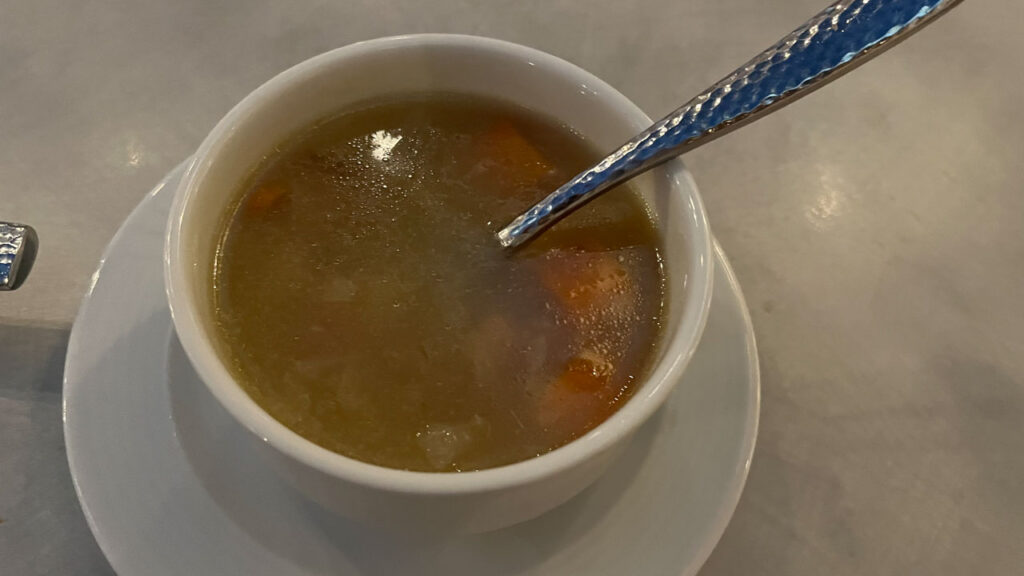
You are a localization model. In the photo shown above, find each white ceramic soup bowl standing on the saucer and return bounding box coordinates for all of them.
[165,34,713,532]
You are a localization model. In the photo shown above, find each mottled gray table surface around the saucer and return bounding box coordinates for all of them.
[0,0,1024,576]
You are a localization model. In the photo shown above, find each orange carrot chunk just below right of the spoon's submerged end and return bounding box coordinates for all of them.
[541,251,636,313]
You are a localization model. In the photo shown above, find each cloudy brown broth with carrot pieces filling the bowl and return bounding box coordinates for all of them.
[211,94,665,471]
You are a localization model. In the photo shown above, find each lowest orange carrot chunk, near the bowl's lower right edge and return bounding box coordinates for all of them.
[537,351,614,430]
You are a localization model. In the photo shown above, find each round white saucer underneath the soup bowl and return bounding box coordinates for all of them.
[63,166,760,576]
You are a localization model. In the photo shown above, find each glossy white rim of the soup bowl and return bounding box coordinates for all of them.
[164,34,714,495]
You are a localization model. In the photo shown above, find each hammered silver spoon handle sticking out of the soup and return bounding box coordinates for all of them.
[497,0,961,248]
